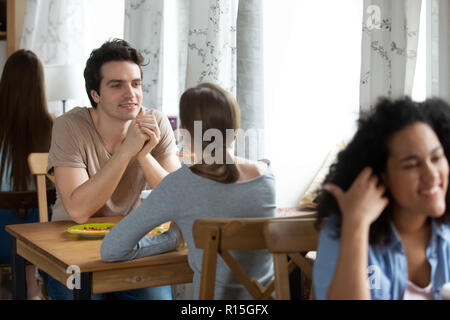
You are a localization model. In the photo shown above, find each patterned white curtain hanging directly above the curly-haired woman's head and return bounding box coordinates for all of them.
[360,0,421,111]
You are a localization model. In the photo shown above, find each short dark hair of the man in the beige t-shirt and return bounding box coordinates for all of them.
[84,39,144,108]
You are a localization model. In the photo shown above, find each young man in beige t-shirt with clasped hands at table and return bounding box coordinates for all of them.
[42,39,181,300]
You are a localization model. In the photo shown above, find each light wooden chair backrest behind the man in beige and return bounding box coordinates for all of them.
[28,153,56,222]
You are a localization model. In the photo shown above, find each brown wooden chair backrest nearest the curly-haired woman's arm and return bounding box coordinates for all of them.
[264,218,319,300]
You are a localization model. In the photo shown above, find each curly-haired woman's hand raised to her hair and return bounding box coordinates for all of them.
[324,167,389,227]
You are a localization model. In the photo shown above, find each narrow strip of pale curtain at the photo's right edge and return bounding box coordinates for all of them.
[427,0,450,102]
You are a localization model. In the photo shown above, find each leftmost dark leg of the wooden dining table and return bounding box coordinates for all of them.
[11,237,27,300]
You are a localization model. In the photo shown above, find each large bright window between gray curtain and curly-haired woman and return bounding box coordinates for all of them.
[264,0,363,207]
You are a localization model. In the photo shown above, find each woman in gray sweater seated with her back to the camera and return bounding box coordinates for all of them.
[101,83,276,299]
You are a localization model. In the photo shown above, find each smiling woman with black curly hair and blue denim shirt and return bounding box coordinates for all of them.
[313,98,450,299]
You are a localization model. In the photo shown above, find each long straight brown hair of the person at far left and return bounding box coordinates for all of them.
[0,50,53,191]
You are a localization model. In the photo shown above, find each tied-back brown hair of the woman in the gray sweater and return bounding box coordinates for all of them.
[180,83,240,183]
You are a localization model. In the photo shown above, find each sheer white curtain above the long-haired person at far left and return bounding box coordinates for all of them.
[20,0,84,64]
